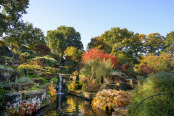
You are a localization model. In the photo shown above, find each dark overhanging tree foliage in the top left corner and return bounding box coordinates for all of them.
[0,0,29,36]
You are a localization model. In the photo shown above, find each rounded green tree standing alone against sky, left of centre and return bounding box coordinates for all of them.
[46,26,83,56]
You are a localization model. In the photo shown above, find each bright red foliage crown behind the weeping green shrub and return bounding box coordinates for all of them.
[82,48,118,67]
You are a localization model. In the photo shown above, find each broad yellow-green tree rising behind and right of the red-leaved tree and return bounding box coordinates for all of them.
[102,27,142,64]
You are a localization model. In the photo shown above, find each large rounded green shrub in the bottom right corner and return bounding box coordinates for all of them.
[127,72,174,116]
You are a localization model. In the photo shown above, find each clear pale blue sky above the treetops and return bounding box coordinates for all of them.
[23,0,174,49]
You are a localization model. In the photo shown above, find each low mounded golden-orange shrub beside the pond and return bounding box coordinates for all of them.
[92,89,130,110]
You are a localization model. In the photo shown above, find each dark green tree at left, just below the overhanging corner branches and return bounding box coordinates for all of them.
[3,23,45,48]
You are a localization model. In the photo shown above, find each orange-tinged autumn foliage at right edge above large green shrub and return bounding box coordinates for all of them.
[134,53,174,76]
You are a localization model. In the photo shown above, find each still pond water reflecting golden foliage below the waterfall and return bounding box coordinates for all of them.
[35,94,111,116]
